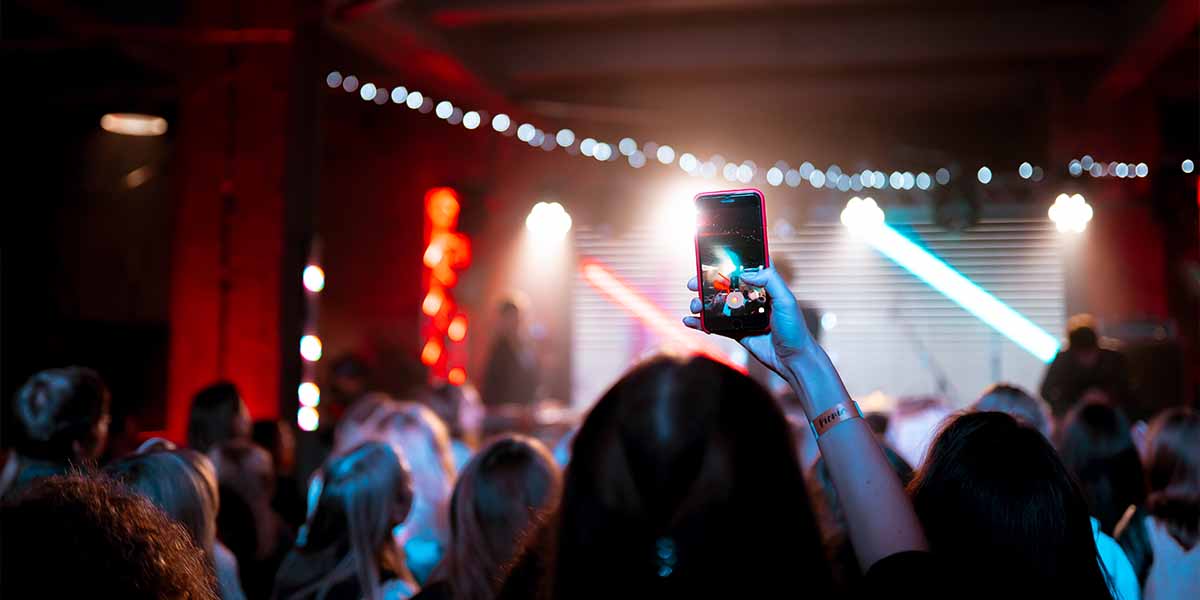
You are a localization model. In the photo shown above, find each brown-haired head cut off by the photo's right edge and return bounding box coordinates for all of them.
[1146,408,1200,548]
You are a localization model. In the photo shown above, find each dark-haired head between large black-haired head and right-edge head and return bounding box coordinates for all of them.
[1057,401,1146,535]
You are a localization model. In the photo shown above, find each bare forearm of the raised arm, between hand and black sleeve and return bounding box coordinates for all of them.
[787,343,928,571]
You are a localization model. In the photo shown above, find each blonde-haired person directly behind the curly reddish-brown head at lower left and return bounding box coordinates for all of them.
[104,443,245,600]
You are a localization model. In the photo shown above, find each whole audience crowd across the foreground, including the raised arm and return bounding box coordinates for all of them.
[0,269,1200,600]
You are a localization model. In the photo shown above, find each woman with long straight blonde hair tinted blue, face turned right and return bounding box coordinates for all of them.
[272,442,416,600]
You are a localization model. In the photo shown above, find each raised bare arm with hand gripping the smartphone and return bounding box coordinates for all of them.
[684,269,928,571]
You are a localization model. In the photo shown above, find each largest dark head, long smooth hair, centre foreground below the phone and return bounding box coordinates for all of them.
[552,358,829,598]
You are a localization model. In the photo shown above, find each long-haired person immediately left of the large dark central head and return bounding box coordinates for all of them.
[416,436,563,600]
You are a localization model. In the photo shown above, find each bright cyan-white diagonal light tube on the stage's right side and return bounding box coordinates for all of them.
[863,224,1060,362]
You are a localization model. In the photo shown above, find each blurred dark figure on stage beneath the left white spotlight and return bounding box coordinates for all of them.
[480,298,538,407]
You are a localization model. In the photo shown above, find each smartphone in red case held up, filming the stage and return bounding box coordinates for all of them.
[695,190,770,335]
